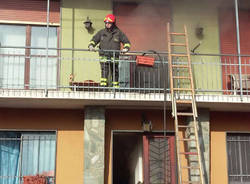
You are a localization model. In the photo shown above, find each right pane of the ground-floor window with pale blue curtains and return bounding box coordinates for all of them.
[22,133,56,184]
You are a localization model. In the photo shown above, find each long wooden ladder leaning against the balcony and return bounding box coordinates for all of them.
[167,23,204,184]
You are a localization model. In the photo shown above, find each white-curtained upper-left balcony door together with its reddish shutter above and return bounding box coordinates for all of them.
[0,0,60,89]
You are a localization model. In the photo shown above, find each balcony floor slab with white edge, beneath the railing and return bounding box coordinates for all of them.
[0,89,250,112]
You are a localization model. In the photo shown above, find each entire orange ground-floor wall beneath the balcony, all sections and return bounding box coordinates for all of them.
[0,109,250,184]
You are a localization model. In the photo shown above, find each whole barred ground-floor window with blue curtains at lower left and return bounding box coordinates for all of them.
[0,131,56,184]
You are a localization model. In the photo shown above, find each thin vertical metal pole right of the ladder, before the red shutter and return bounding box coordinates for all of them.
[235,0,243,100]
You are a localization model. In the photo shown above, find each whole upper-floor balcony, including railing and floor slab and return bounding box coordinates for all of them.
[0,47,250,109]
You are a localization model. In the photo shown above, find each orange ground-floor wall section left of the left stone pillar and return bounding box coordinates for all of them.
[0,109,84,184]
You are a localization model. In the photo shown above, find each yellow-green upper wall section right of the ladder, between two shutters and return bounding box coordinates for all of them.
[172,0,222,90]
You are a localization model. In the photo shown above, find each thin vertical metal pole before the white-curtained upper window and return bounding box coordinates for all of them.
[45,0,50,96]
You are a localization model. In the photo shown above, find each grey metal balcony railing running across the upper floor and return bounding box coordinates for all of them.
[0,47,250,95]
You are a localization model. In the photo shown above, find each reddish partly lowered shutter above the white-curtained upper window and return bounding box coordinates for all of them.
[0,0,60,23]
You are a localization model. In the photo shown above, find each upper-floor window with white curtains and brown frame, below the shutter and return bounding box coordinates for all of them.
[0,25,58,89]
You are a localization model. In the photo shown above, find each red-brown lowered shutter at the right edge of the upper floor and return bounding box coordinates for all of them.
[219,9,250,94]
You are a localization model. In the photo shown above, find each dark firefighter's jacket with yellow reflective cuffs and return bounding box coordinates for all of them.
[89,26,130,57]
